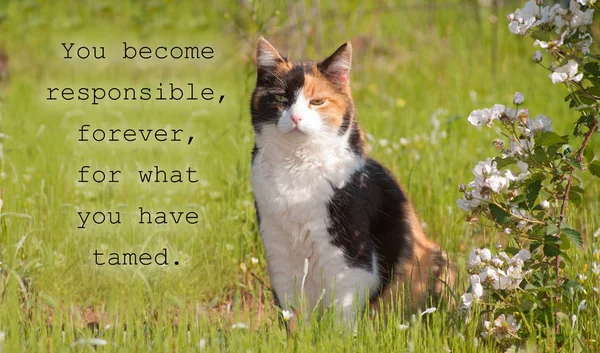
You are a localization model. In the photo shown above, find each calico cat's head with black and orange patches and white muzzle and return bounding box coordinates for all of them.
[251,38,354,147]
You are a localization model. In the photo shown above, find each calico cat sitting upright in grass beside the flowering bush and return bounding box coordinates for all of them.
[251,37,453,320]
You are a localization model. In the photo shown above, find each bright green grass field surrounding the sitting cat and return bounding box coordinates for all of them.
[0,0,600,352]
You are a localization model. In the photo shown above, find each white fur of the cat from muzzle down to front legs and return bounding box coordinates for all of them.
[252,90,379,320]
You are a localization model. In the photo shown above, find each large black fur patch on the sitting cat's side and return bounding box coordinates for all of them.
[328,158,412,293]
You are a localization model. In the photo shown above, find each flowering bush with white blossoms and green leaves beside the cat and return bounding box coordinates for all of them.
[457,0,600,347]
